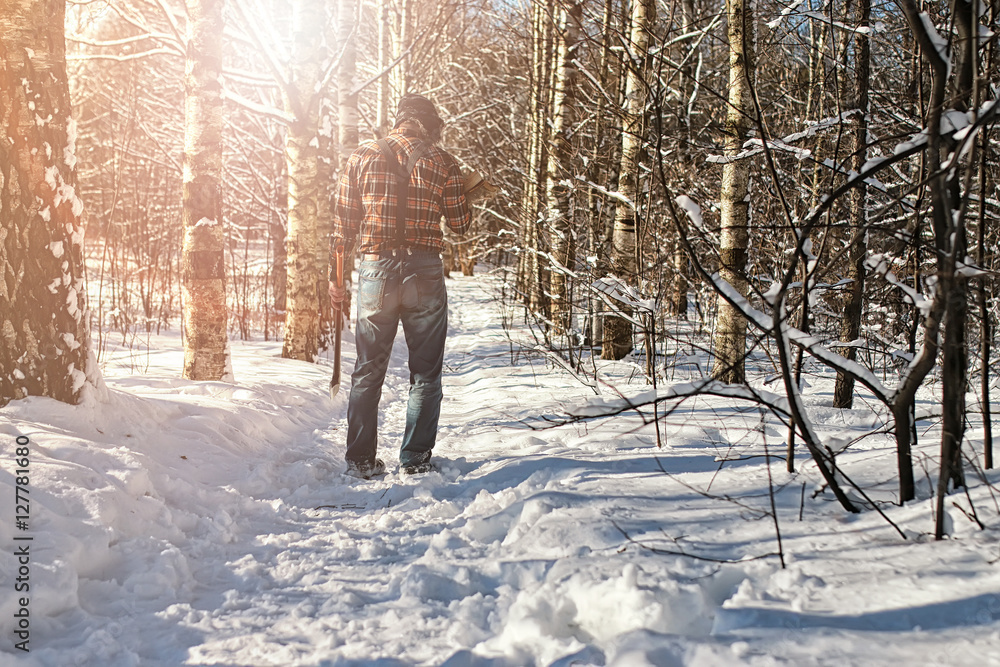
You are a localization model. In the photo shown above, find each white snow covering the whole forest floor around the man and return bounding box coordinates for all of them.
[0,277,1000,667]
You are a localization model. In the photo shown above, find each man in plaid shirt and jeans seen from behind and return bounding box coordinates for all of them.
[330,95,471,479]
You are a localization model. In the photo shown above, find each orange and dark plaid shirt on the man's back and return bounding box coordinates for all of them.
[333,129,472,253]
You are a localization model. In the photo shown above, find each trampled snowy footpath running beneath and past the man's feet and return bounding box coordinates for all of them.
[171,279,600,664]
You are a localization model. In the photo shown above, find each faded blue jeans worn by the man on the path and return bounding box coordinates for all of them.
[346,253,448,466]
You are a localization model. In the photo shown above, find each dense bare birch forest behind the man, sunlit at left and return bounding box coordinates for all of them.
[0,0,1000,537]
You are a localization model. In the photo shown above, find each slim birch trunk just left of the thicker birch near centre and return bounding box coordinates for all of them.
[545,2,583,334]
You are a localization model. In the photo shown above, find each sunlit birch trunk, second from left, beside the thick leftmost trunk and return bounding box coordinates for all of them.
[181,0,233,381]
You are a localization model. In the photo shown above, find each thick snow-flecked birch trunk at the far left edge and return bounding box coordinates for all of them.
[0,0,103,405]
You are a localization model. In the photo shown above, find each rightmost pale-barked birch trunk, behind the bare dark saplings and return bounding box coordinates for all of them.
[712,0,754,384]
